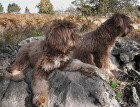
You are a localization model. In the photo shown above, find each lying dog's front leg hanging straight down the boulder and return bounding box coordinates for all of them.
[32,68,49,107]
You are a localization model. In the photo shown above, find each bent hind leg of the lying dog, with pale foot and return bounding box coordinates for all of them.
[10,51,29,81]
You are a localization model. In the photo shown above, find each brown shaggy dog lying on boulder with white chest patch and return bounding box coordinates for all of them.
[10,20,94,106]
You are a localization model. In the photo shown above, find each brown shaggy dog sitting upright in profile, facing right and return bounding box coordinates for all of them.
[74,13,133,77]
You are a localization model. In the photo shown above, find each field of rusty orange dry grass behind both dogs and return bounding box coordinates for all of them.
[0,13,140,44]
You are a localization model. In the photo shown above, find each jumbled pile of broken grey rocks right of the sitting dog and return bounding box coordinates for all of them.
[112,40,140,107]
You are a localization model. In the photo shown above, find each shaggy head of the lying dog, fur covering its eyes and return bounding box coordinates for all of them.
[46,20,80,53]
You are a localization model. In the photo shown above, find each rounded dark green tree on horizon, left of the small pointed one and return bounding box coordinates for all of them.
[7,3,21,13]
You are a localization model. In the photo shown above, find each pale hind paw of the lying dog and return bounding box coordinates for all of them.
[11,71,25,81]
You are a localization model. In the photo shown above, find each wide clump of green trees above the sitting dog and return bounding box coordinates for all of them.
[72,0,138,16]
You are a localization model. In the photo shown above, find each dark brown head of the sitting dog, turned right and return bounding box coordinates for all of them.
[109,13,133,37]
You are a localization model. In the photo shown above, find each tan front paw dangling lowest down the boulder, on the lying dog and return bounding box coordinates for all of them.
[33,94,48,107]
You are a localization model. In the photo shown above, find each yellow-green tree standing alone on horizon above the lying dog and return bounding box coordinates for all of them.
[37,0,54,14]
